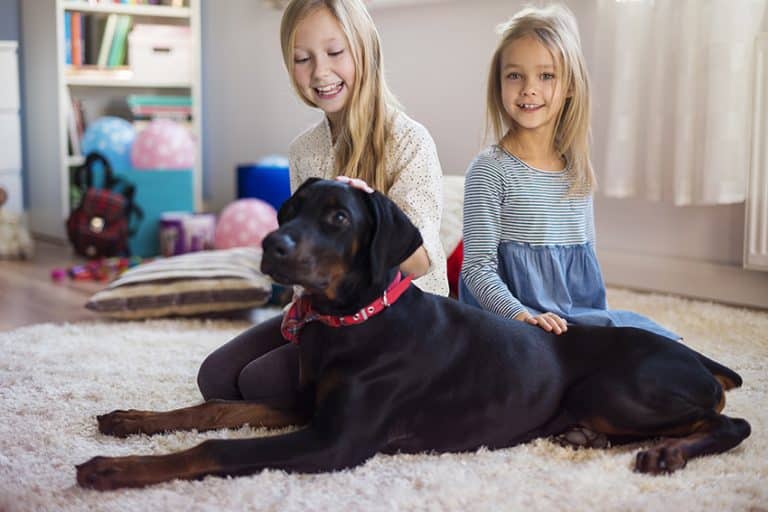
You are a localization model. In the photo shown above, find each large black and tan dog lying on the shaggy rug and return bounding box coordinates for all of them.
[77,179,750,490]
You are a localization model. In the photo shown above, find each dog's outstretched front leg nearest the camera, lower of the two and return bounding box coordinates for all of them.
[77,428,376,491]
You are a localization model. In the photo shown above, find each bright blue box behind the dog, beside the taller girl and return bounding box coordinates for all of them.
[237,157,291,210]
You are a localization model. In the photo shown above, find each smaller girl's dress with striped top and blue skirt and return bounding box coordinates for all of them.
[459,145,680,340]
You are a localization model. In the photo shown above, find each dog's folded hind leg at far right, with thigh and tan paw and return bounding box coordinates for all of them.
[563,353,750,474]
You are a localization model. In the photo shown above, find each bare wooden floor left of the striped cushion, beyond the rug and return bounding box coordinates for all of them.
[0,240,104,332]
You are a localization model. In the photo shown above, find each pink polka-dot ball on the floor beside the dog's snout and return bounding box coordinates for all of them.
[213,199,277,249]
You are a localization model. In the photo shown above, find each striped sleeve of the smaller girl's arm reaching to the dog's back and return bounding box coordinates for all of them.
[461,155,525,318]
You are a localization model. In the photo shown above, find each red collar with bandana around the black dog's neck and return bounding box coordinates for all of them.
[280,272,413,343]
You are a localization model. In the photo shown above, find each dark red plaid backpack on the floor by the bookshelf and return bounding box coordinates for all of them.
[67,153,143,259]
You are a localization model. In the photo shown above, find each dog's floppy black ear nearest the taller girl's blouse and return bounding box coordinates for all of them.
[365,192,423,282]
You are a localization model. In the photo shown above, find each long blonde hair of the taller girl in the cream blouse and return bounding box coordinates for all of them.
[280,0,399,194]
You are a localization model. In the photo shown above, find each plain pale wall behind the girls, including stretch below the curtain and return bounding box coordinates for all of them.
[203,0,768,308]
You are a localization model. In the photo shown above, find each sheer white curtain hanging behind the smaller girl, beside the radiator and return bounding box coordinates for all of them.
[582,0,768,205]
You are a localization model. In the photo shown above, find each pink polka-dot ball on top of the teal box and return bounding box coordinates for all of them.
[131,119,196,169]
